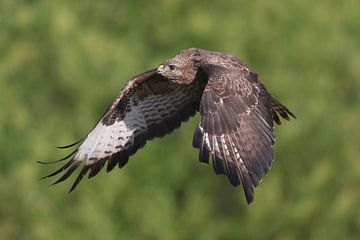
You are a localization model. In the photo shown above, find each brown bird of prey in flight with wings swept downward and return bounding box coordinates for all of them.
[41,48,295,203]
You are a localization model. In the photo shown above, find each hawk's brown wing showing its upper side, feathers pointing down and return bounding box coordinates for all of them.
[193,65,275,203]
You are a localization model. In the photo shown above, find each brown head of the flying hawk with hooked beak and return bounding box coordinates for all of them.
[157,48,204,84]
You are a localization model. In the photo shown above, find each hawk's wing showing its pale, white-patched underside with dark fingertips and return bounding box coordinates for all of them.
[40,69,205,191]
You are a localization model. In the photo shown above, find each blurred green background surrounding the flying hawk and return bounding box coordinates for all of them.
[0,0,360,240]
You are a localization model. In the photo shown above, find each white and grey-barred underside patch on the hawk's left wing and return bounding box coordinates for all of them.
[74,88,192,165]
